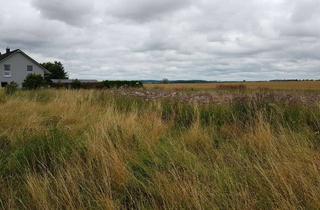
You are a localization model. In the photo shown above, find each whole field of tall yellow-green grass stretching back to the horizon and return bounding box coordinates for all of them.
[0,88,320,210]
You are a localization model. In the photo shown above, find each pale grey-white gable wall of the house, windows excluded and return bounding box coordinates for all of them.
[0,53,44,87]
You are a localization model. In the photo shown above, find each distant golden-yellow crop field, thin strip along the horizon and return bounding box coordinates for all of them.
[144,81,320,90]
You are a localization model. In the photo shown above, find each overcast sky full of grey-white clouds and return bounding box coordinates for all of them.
[0,0,320,81]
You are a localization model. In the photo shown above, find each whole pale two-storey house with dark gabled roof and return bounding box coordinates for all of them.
[0,48,49,87]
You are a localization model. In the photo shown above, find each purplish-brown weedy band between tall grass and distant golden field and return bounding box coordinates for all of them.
[113,89,320,104]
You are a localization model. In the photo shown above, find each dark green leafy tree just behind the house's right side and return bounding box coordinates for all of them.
[41,61,68,83]
